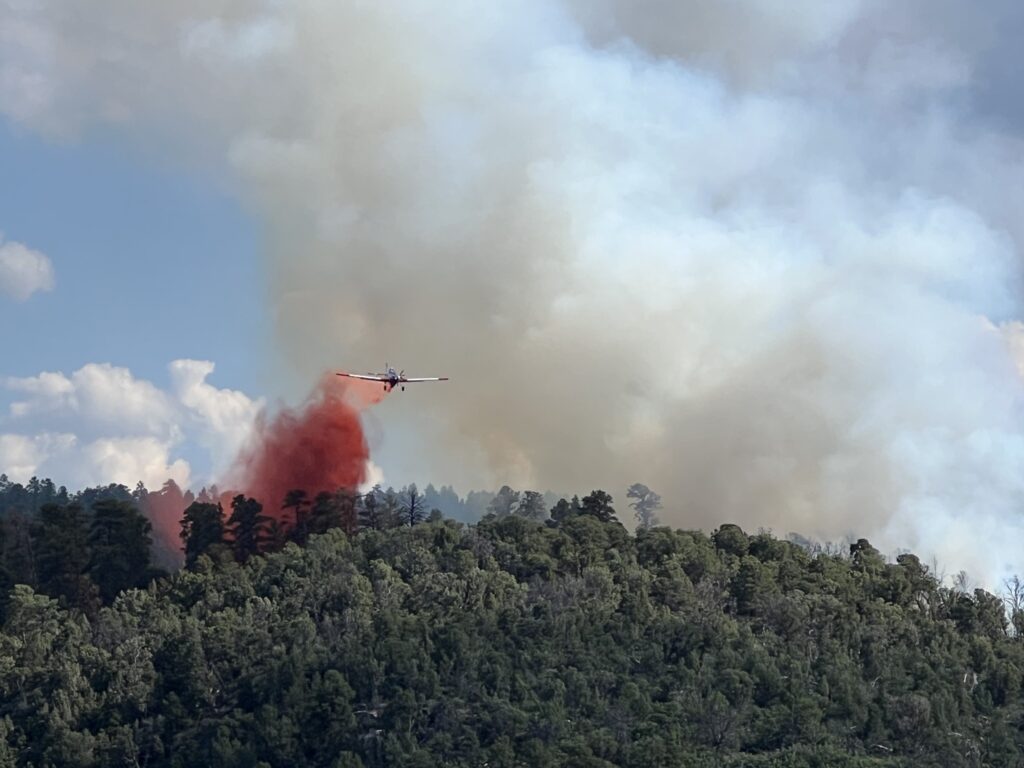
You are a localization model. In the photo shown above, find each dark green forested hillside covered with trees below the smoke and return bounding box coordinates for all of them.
[0,473,1024,768]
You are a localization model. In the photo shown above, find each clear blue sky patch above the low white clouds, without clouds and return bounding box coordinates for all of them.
[0,121,267,392]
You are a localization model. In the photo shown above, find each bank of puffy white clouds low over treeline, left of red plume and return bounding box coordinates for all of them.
[0,359,262,487]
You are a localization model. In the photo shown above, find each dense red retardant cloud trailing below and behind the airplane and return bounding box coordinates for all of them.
[225,374,370,523]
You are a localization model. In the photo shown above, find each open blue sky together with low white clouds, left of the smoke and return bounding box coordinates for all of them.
[0,121,267,487]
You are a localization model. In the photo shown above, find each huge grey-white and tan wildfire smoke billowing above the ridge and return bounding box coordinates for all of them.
[6,0,1024,579]
